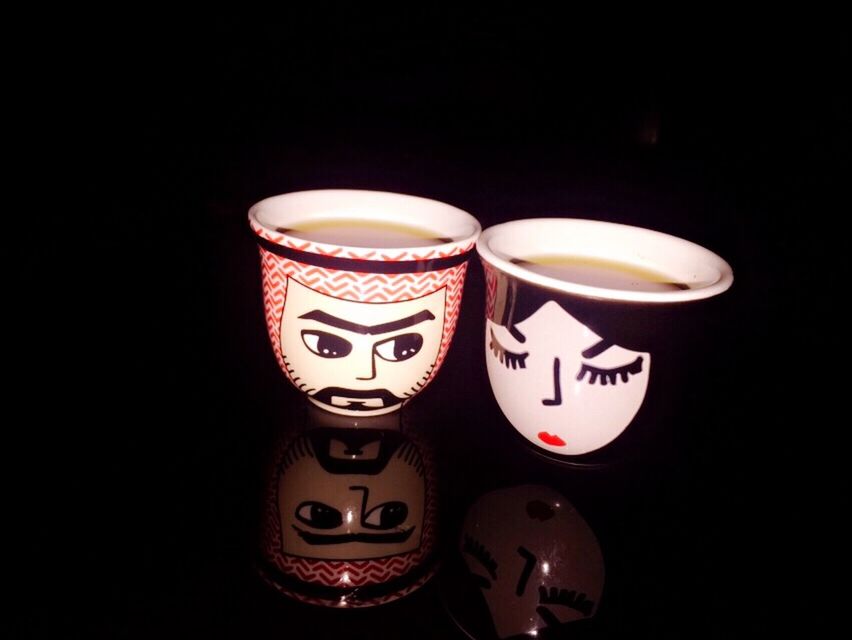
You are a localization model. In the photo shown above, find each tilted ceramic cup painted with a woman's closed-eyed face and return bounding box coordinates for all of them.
[477,218,733,461]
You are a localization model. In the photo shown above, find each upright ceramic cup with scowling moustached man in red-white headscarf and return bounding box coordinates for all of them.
[249,190,480,416]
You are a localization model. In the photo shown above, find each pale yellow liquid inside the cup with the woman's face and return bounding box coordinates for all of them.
[512,255,689,291]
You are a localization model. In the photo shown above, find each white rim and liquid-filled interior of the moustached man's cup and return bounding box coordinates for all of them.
[249,189,480,252]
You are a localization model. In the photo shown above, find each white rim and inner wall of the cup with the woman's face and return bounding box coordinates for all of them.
[476,218,734,304]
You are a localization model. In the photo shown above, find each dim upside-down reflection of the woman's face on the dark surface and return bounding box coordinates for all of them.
[461,485,604,638]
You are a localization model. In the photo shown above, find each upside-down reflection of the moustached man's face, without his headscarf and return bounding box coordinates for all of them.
[278,429,426,560]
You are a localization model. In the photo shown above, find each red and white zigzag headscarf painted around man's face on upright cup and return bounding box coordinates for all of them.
[260,248,467,387]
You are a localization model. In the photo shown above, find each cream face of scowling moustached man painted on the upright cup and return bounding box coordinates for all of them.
[281,278,445,415]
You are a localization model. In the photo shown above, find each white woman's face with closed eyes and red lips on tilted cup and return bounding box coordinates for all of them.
[485,300,651,455]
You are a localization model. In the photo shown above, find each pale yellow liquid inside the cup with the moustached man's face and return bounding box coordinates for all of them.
[277,219,452,249]
